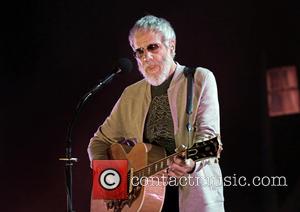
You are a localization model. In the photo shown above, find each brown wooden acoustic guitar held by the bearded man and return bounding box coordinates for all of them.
[91,137,219,212]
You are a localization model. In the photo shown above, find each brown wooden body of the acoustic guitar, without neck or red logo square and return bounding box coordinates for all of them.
[91,143,166,212]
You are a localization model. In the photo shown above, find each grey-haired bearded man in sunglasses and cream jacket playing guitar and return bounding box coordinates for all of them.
[88,15,224,212]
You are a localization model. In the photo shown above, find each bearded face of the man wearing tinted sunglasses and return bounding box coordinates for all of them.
[133,31,176,86]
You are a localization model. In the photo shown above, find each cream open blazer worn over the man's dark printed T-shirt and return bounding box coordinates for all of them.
[88,64,224,212]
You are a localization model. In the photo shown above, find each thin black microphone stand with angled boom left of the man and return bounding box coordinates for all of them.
[59,69,122,212]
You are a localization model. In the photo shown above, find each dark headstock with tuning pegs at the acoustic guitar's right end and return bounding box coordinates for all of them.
[186,137,219,161]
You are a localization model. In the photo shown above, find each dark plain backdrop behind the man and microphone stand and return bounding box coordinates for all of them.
[0,0,300,212]
